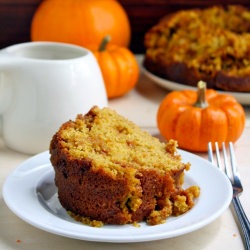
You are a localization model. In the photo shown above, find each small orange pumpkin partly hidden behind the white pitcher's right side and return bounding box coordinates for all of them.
[93,36,140,98]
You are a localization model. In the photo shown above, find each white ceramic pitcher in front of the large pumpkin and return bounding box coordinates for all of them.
[0,42,107,154]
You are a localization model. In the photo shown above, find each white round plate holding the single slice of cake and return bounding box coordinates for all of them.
[3,150,232,243]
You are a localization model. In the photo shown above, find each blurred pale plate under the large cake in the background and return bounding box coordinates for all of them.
[142,66,250,105]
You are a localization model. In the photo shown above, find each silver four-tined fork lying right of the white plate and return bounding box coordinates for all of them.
[208,142,250,250]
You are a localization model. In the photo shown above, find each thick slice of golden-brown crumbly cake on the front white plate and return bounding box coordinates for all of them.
[50,107,199,226]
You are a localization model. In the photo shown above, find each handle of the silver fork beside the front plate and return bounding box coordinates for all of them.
[232,195,250,250]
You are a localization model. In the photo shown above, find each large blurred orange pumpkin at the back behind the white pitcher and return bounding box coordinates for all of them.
[31,0,131,49]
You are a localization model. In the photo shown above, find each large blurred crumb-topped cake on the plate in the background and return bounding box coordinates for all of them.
[144,5,250,92]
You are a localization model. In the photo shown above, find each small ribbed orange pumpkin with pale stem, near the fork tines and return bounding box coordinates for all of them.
[157,81,245,152]
